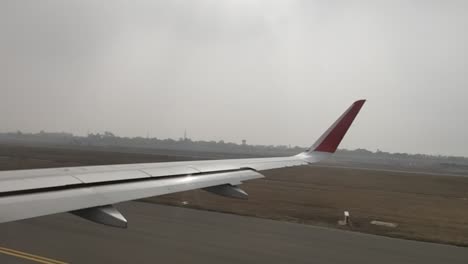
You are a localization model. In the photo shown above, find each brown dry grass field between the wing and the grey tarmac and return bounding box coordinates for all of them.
[146,166,468,246]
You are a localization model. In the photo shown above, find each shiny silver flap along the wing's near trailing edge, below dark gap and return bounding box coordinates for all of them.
[0,170,263,223]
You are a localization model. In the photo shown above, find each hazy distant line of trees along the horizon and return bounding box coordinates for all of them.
[0,131,468,166]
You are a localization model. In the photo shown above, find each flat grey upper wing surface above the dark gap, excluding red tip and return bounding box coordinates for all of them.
[0,157,306,196]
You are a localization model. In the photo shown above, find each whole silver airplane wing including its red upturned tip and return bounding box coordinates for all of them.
[0,100,365,227]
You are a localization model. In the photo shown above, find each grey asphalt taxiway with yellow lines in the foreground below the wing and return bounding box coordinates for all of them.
[0,202,468,264]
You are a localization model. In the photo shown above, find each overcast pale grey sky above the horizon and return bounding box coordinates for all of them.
[0,0,468,156]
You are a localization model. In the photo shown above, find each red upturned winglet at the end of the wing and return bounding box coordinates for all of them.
[306,100,366,153]
